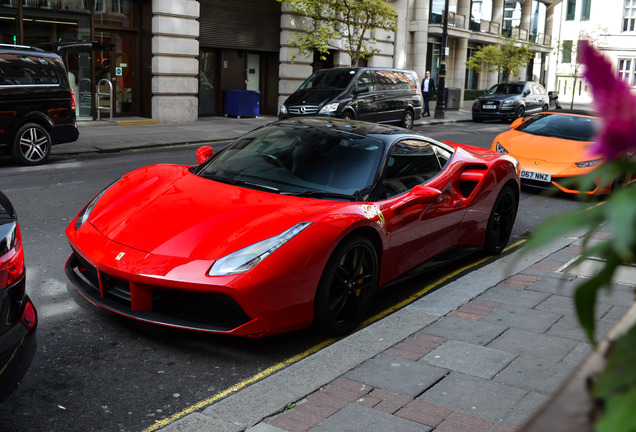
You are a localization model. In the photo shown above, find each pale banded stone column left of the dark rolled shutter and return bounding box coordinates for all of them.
[152,0,199,123]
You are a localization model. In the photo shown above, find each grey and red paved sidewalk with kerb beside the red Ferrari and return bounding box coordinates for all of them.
[149,228,636,432]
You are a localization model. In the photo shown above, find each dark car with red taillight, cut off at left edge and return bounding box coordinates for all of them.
[0,192,37,401]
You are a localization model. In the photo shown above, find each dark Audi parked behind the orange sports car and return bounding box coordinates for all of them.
[473,81,550,122]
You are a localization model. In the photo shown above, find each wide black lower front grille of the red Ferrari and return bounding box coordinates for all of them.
[66,252,250,331]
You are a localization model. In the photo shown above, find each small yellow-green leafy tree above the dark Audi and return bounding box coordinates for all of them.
[466,38,534,81]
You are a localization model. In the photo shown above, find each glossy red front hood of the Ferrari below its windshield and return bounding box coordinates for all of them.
[89,165,336,259]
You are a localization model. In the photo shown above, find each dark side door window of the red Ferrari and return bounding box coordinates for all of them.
[382,140,451,198]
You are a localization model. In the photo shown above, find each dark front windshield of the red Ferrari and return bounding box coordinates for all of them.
[197,124,384,200]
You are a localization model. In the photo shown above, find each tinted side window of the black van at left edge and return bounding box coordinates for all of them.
[0,53,60,85]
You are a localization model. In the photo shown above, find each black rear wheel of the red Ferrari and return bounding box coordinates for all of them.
[484,186,517,255]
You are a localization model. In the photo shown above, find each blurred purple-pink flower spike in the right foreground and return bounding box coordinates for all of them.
[579,40,636,159]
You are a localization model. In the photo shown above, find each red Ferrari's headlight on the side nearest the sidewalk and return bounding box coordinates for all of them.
[208,222,311,276]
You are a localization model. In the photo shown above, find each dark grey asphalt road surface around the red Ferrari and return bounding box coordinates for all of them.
[0,123,580,432]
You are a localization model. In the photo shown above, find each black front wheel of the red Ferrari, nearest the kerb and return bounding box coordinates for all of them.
[314,236,379,336]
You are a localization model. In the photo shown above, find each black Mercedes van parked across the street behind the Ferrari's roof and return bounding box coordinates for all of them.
[278,67,422,129]
